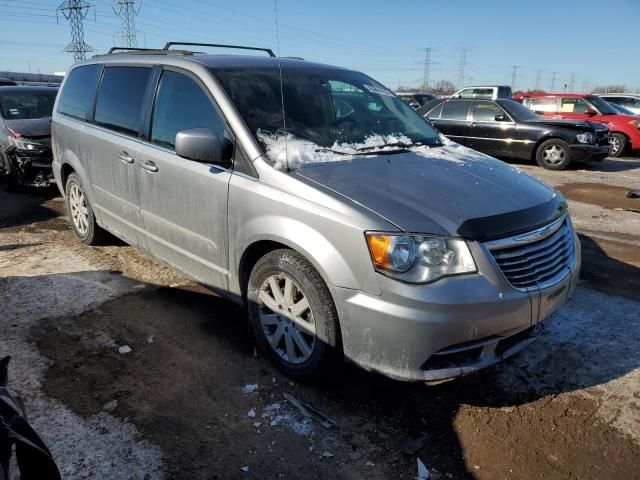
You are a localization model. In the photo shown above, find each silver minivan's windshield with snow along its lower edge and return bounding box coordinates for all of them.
[213,65,440,157]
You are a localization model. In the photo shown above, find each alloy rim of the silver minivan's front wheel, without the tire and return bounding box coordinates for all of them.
[258,274,316,364]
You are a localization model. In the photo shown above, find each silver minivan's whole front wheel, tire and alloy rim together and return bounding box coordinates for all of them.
[247,249,342,380]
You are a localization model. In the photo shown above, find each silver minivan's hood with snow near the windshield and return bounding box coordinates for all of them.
[294,144,564,236]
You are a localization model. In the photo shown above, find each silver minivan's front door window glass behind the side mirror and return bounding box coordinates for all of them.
[151,71,224,149]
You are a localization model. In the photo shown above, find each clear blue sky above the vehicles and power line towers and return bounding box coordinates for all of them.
[0,0,640,90]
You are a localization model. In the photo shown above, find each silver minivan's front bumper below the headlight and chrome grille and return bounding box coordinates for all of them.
[334,237,580,381]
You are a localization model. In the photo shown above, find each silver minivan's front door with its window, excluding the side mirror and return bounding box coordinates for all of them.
[137,69,231,289]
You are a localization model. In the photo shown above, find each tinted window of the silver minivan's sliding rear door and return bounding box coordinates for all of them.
[95,67,151,134]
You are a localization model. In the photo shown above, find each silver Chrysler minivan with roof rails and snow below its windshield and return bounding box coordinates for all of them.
[52,44,580,380]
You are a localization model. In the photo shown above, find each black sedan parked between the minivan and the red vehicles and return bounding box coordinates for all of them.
[417,99,609,170]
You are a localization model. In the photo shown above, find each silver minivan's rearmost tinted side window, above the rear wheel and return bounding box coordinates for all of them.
[58,65,100,120]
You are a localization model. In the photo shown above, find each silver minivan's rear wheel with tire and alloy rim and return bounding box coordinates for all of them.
[64,173,105,245]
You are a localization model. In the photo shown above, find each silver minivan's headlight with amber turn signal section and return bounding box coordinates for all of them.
[366,232,476,283]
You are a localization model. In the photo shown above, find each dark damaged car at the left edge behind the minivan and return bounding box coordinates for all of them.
[0,86,58,191]
